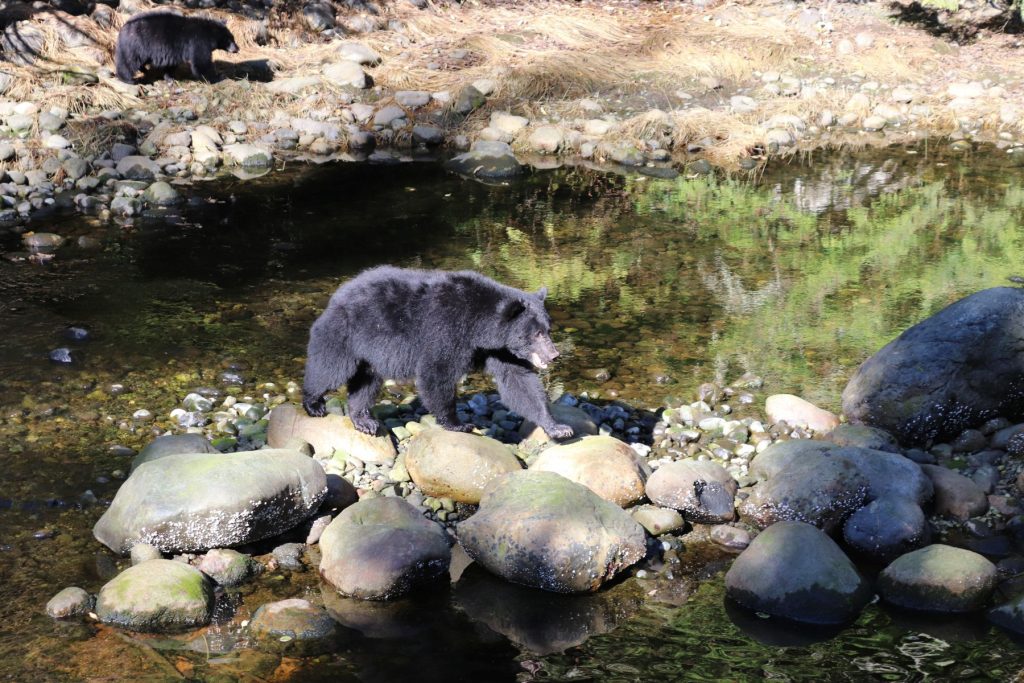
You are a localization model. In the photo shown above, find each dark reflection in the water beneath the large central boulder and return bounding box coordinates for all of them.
[453,565,643,654]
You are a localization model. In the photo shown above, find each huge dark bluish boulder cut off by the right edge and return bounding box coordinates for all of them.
[843,287,1024,444]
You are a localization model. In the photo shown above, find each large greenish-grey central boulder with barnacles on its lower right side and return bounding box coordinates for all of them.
[458,470,646,593]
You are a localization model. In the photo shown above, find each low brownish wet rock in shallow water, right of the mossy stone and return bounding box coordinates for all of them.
[249,598,338,656]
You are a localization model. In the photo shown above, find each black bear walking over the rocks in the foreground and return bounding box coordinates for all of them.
[302,266,572,438]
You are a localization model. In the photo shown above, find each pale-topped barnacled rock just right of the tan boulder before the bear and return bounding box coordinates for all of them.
[647,460,737,524]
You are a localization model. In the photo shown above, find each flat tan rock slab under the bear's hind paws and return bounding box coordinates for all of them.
[266,403,398,465]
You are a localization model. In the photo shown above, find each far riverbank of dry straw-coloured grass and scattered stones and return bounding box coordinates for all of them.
[0,0,1024,224]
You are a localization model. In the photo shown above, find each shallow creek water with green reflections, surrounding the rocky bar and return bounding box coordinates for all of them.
[0,145,1024,681]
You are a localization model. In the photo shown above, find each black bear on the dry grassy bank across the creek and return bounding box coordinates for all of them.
[114,12,239,83]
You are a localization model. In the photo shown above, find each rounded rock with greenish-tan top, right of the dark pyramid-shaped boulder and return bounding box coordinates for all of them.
[878,544,996,612]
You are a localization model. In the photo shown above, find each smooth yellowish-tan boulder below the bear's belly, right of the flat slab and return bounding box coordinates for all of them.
[406,429,522,504]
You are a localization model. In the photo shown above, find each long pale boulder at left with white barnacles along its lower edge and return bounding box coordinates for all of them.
[92,449,327,554]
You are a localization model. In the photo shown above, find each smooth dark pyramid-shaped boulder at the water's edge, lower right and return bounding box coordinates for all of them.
[725,521,872,624]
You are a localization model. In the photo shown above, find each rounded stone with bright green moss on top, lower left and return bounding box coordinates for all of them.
[96,560,213,631]
